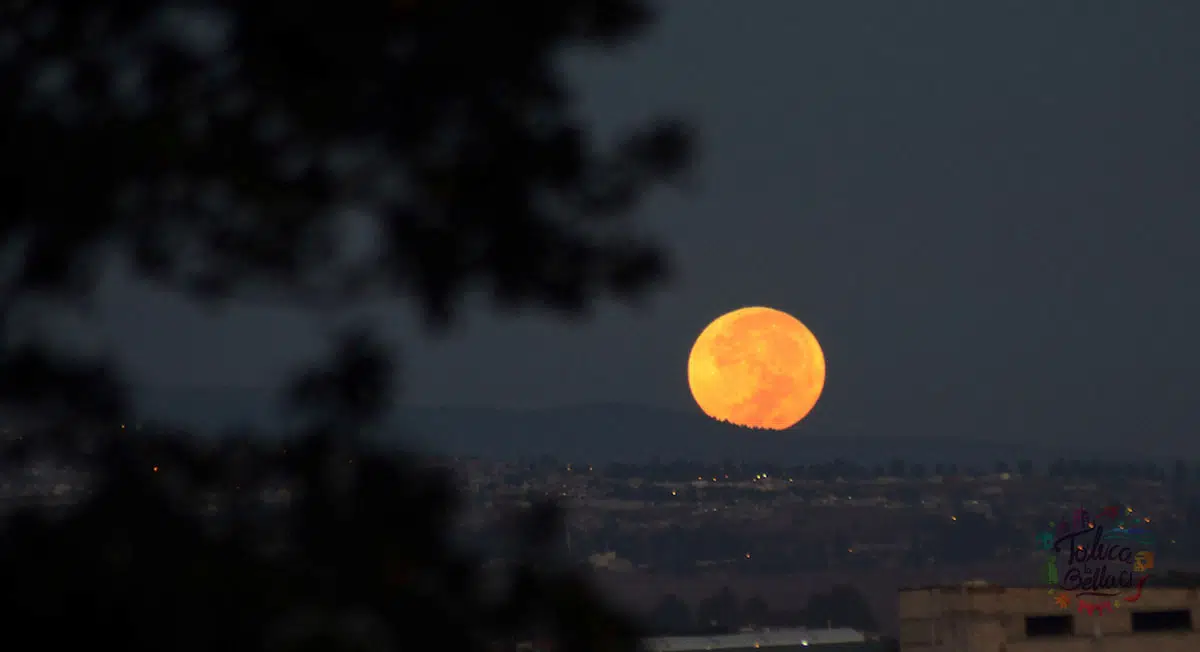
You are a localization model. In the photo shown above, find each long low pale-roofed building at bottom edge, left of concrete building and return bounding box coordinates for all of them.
[642,628,882,652]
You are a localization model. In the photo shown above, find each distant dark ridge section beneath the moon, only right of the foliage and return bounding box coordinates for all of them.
[403,405,1120,468]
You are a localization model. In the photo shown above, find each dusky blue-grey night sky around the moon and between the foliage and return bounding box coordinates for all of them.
[82,0,1200,450]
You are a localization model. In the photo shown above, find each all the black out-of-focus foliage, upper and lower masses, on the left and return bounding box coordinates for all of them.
[0,0,690,652]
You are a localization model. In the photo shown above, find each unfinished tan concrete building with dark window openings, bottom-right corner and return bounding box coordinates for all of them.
[899,582,1200,652]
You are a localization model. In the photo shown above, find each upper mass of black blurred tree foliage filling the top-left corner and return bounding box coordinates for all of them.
[0,0,689,321]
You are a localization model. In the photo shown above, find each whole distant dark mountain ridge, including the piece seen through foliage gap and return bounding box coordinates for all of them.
[139,389,1127,468]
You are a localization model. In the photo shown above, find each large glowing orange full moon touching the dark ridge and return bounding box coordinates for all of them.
[688,307,824,430]
